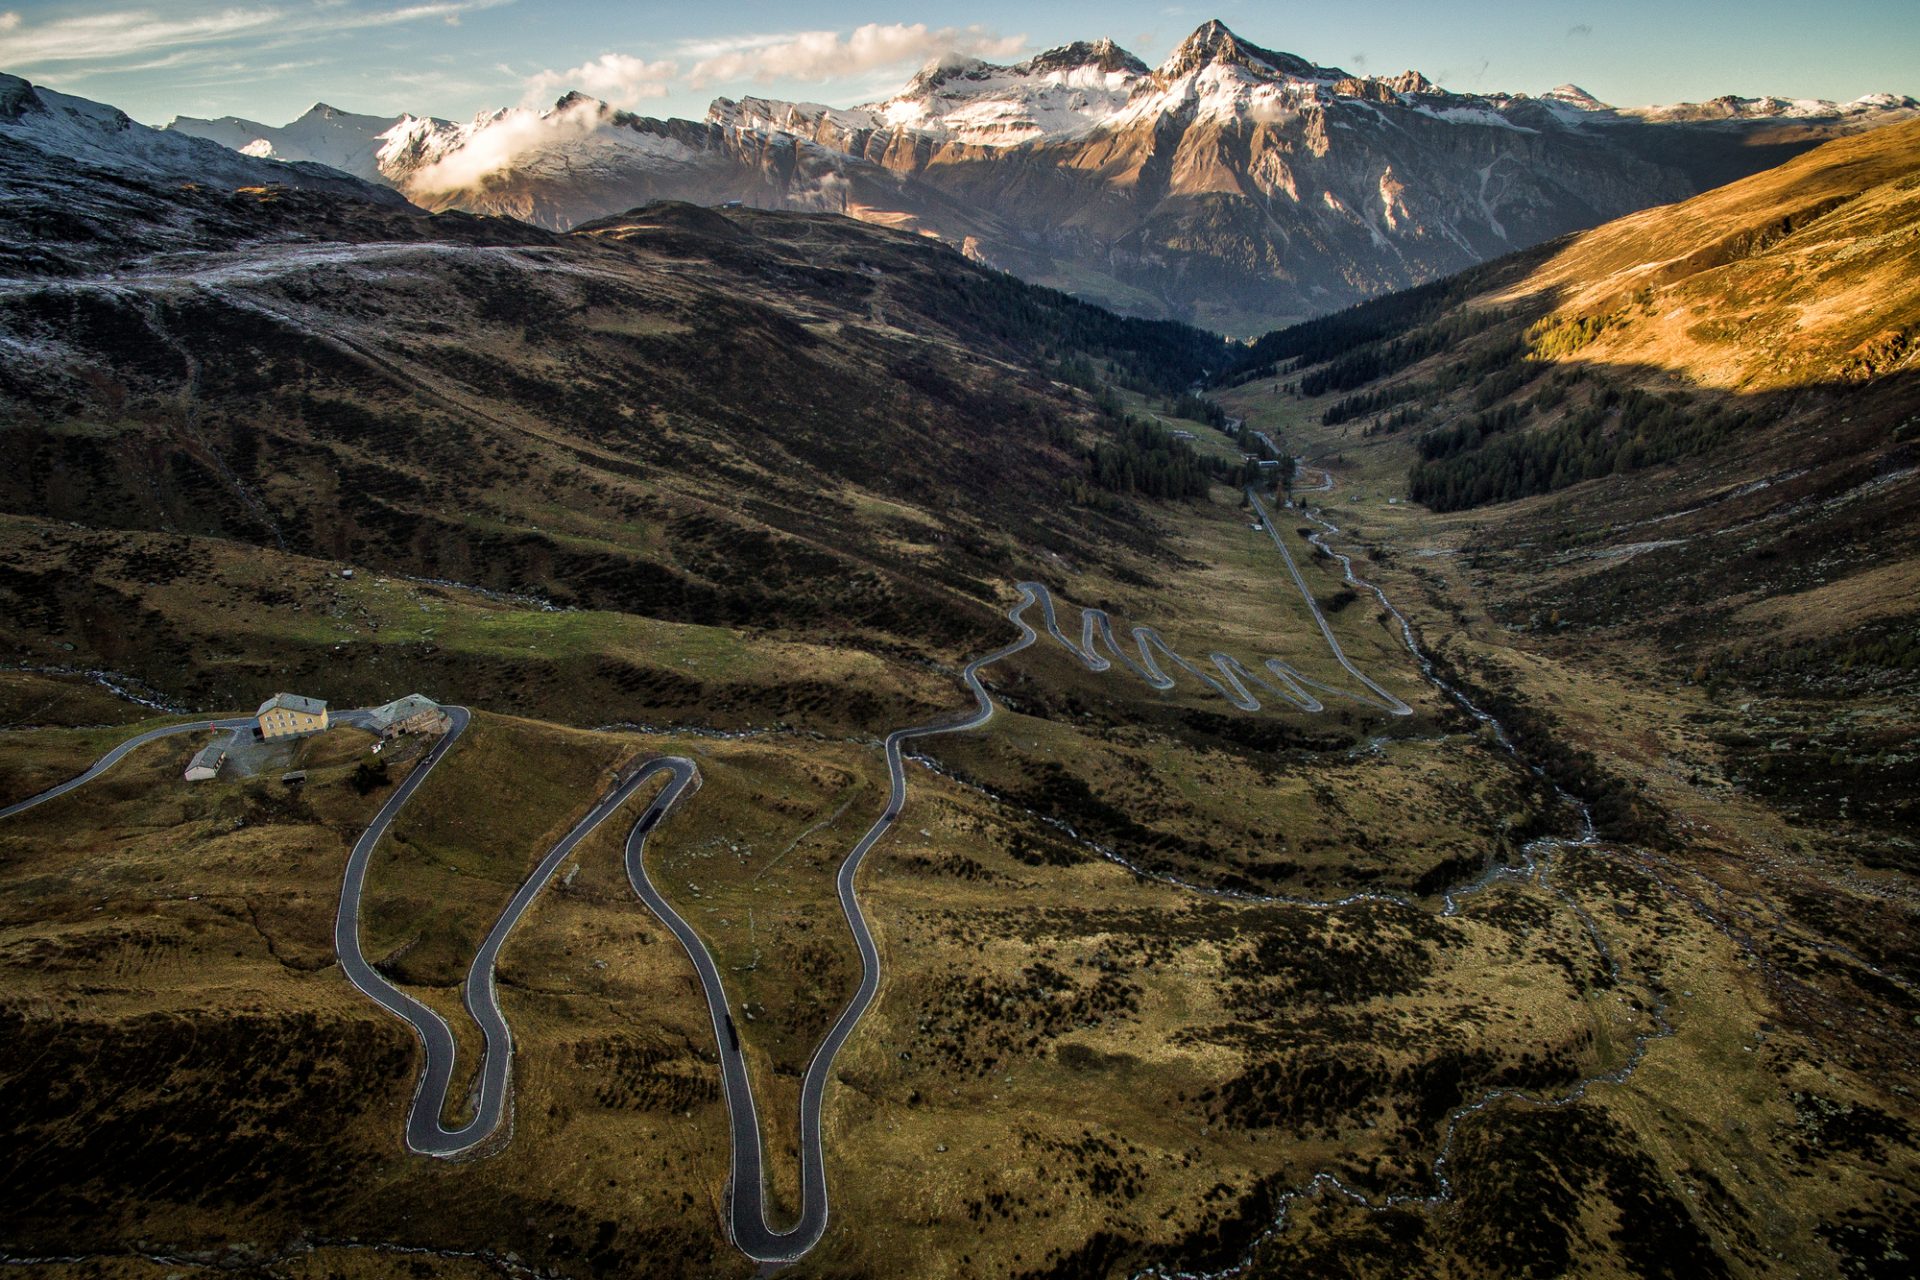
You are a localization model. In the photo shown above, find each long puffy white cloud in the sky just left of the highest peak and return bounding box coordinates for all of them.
[687,23,1027,88]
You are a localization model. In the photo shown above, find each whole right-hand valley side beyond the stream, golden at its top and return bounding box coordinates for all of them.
[1225,117,1920,1276]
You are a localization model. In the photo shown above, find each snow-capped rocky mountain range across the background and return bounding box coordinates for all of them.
[165,21,1920,334]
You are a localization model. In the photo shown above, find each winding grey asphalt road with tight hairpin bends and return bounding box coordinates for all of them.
[0,489,1411,1265]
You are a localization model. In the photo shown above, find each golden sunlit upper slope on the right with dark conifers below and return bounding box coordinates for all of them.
[1236,125,1920,510]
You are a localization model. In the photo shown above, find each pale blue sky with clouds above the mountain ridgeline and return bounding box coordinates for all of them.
[0,0,1920,125]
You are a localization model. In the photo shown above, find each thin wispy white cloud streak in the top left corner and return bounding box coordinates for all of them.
[0,0,513,71]
